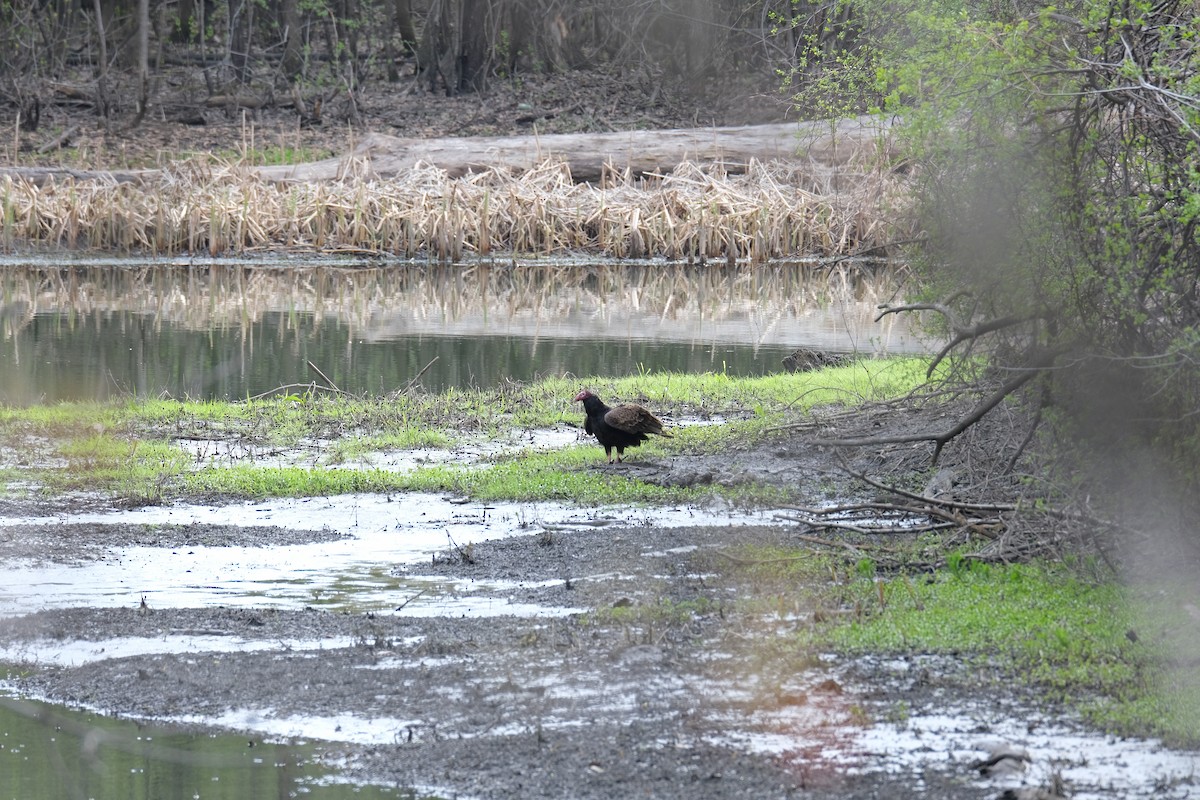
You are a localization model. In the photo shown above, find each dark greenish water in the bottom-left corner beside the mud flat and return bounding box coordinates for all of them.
[0,698,403,800]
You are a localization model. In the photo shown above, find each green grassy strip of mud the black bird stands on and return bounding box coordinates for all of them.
[0,359,926,504]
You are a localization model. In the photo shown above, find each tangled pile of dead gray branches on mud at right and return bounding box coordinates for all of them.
[768,379,1140,570]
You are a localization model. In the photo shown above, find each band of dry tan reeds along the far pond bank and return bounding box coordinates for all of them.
[0,162,904,261]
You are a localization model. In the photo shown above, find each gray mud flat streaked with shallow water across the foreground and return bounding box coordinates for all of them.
[0,513,1195,800]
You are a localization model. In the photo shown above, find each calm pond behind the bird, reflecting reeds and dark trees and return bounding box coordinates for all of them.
[0,261,922,404]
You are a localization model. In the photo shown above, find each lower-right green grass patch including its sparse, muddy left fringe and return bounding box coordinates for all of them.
[710,541,1200,747]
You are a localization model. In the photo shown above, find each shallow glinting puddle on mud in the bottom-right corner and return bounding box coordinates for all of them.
[713,661,1200,800]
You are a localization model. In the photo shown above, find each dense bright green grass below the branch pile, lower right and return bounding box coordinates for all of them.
[797,559,1200,745]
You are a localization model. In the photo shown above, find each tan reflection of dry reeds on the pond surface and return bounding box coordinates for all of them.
[0,261,900,335]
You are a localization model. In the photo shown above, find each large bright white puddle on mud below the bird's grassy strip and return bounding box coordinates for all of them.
[0,494,767,616]
